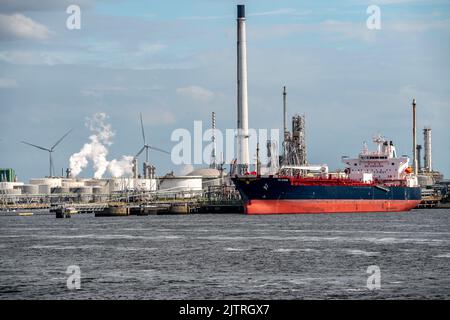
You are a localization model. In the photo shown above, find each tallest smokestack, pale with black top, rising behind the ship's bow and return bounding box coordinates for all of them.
[237,4,249,173]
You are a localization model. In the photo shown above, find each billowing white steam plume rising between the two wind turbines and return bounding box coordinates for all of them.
[69,113,133,179]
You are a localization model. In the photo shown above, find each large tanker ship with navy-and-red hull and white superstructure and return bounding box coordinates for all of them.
[232,137,421,214]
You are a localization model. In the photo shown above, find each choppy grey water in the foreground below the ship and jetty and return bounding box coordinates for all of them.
[0,210,450,299]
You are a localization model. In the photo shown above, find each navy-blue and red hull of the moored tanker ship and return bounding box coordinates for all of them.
[233,177,421,214]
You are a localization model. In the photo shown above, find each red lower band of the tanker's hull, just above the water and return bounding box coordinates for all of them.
[245,200,420,214]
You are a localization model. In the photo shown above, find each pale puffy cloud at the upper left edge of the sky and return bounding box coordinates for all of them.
[0,13,51,40]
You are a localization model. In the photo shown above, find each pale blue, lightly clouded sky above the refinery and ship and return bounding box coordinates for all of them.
[0,0,450,181]
